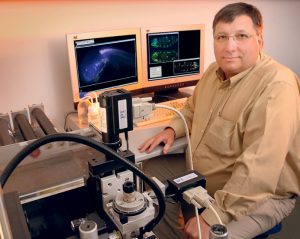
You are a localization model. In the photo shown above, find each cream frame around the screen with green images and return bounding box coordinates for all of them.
[141,24,205,93]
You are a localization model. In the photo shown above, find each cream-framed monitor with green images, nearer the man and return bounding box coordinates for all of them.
[141,24,204,99]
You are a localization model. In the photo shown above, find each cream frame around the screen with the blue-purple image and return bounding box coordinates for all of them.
[67,28,142,108]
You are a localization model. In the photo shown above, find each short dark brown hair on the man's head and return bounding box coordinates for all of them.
[213,2,263,33]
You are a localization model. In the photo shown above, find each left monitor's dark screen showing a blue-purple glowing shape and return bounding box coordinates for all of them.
[74,35,138,98]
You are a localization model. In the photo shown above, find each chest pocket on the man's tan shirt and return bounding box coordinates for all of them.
[204,115,239,157]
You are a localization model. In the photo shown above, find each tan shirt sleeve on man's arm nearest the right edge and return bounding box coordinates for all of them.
[202,81,300,224]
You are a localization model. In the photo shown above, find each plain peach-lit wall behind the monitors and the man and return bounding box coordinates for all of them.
[0,0,300,126]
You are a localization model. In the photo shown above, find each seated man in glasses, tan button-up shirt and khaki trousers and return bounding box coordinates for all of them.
[139,3,300,239]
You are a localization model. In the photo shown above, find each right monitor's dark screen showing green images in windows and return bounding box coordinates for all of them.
[147,30,201,80]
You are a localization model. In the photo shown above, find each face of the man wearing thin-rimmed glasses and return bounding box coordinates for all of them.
[214,15,263,78]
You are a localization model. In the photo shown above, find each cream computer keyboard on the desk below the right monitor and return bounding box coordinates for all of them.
[134,98,187,127]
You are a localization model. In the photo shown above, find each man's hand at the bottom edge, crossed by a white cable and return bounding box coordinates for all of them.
[183,216,210,239]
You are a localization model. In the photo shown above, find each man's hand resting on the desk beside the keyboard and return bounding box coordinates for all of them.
[138,128,175,154]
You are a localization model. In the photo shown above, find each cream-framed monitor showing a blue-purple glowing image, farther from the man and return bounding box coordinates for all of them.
[67,28,142,107]
